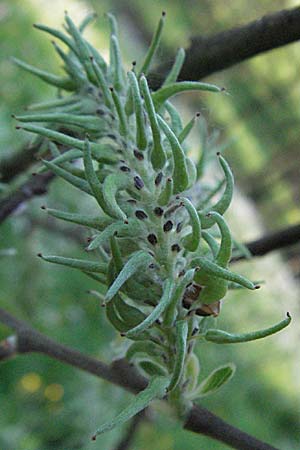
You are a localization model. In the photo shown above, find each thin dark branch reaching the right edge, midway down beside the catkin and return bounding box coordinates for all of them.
[232,224,300,262]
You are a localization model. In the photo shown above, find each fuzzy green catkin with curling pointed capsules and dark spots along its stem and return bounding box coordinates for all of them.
[16,14,291,439]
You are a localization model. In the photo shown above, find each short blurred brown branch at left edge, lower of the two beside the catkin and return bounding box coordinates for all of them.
[0,172,54,223]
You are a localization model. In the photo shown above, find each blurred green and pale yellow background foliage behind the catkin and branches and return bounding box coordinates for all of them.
[0,0,300,450]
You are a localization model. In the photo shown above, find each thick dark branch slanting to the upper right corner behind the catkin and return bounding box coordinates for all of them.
[150,7,300,89]
